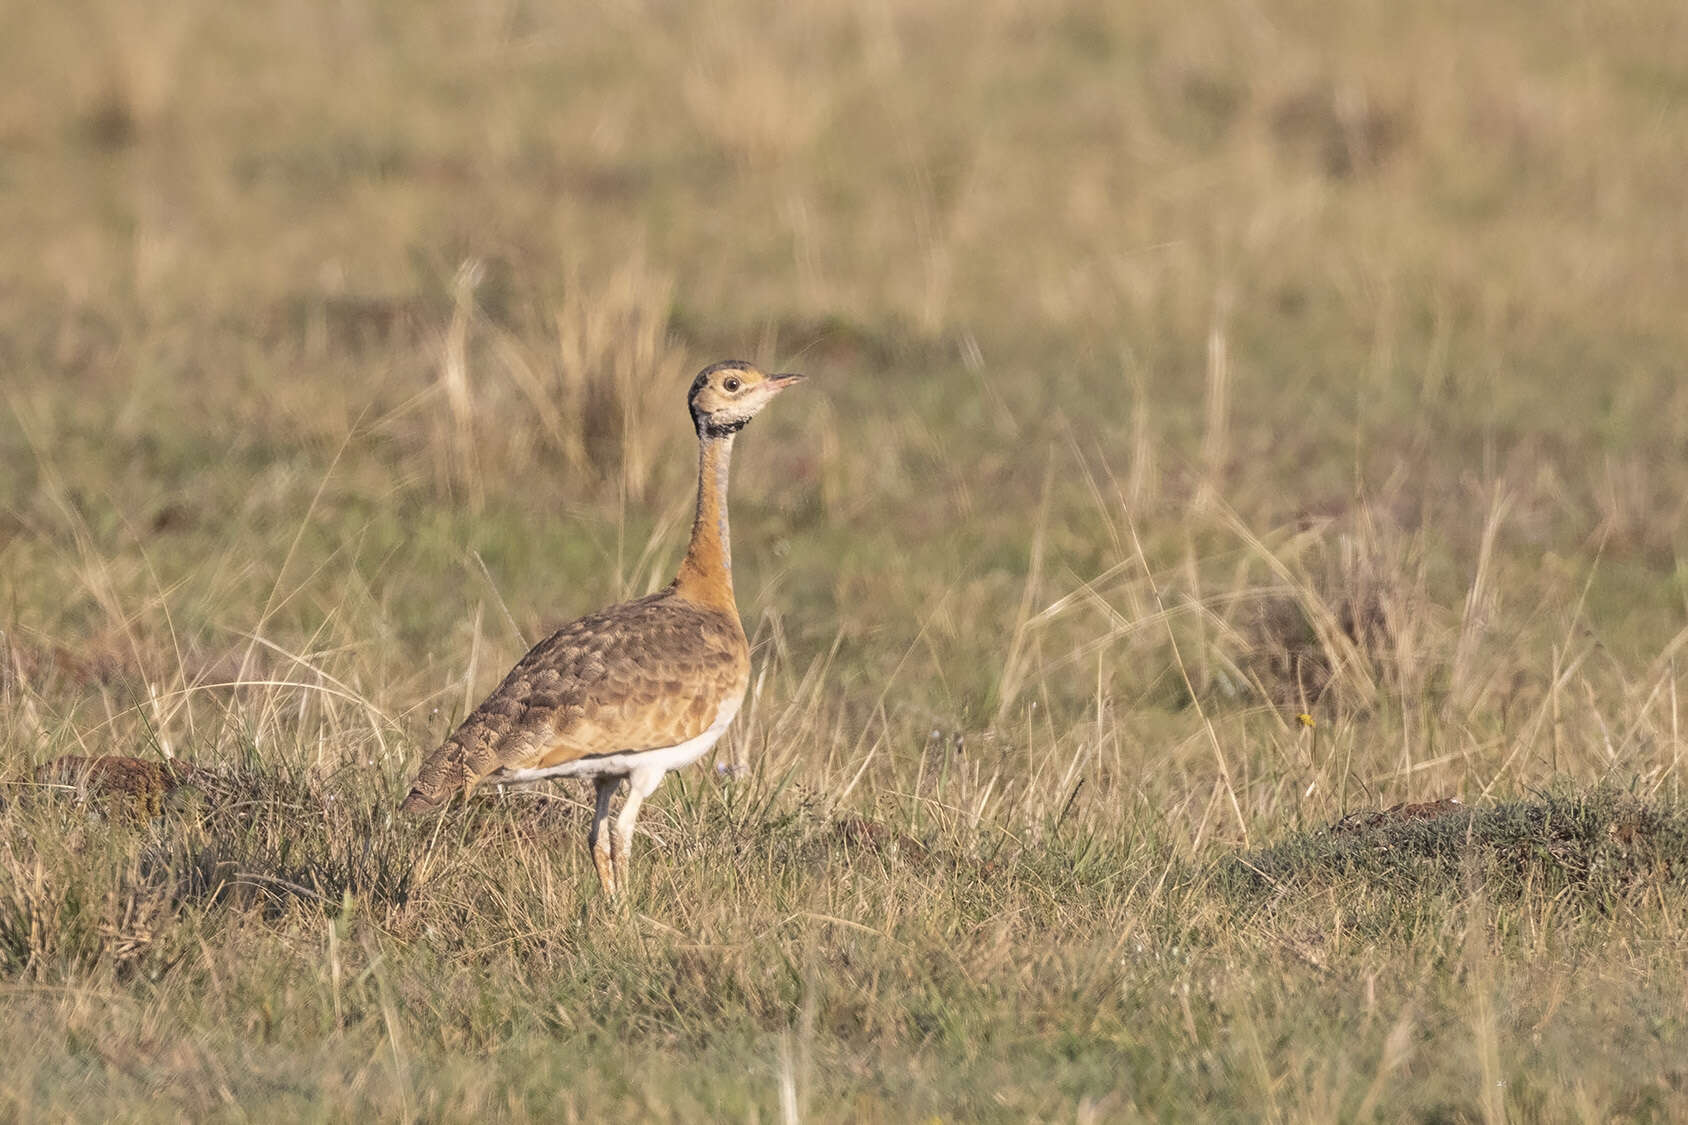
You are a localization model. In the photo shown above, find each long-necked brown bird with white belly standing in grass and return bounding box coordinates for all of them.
[400,360,803,899]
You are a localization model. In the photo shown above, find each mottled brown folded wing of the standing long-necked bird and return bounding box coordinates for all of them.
[403,593,748,809]
